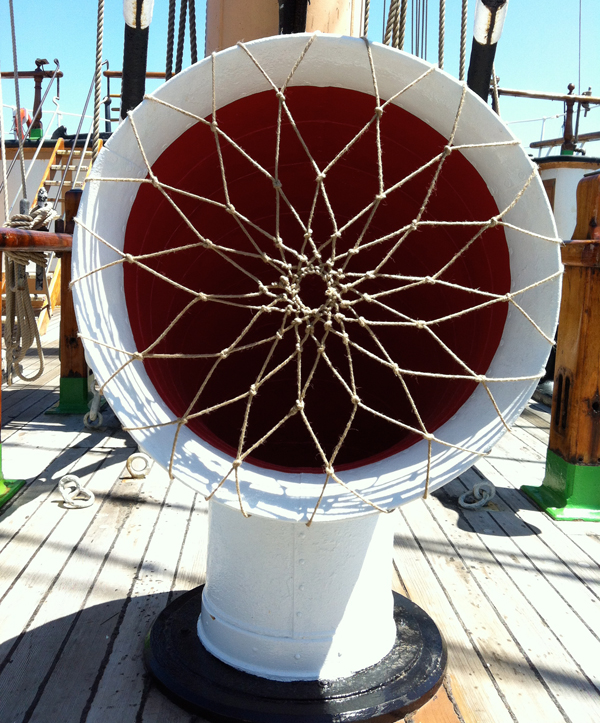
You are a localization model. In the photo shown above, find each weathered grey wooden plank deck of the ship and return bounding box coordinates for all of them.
[0,320,600,723]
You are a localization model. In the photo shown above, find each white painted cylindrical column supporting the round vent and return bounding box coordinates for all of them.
[198,501,396,681]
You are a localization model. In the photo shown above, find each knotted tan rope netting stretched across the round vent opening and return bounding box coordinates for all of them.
[71,36,560,524]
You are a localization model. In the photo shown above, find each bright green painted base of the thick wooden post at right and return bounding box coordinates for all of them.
[521,449,600,522]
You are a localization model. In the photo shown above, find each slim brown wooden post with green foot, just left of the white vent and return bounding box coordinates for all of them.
[47,188,91,414]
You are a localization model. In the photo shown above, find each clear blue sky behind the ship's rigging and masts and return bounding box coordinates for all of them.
[0,0,600,156]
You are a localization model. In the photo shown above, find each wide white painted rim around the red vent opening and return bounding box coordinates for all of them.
[73,35,561,520]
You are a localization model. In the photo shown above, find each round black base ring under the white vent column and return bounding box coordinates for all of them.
[144,586,447,723]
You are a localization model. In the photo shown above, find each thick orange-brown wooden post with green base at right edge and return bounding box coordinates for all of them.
[521,173,600,521]
